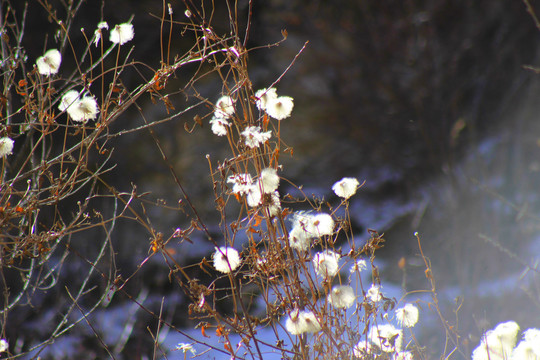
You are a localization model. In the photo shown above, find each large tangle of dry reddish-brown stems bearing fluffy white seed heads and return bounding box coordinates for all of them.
[7,0,536,360]
